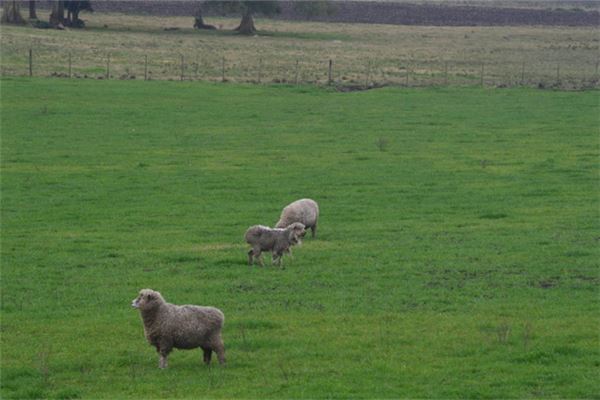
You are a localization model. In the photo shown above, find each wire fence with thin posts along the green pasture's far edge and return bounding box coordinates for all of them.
[0,49,600,90]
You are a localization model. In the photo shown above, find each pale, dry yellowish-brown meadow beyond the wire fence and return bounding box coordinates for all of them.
[0,10,599,89]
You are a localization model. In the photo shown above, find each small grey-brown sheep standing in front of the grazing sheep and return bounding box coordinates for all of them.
[244,222,306,267]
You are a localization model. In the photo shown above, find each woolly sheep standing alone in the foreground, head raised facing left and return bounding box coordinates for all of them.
[131,289,225,368]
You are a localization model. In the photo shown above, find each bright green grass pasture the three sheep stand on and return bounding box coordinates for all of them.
[0,78,600,399]
